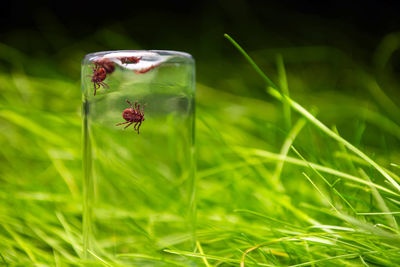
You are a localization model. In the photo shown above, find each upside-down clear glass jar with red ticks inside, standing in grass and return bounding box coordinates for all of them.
[82,50,195,266]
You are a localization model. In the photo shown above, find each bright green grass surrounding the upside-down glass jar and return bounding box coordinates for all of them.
[0,31,400,267]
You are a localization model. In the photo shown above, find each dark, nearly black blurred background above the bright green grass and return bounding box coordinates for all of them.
[0,0,400,98]
